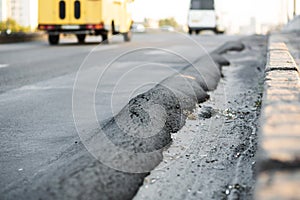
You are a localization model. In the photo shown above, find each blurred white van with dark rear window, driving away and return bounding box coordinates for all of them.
[188,0,224,34]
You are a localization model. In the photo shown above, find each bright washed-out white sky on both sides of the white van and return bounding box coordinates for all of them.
[132,0,300,25]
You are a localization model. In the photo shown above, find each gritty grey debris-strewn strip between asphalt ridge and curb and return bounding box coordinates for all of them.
[134,36,267,200]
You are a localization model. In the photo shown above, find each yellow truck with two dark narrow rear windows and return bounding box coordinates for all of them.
[38,0,134,45]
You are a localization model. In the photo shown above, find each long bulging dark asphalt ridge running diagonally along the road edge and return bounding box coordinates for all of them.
[11,39,244,199]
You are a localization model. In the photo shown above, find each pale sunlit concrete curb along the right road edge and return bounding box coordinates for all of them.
[255,34,300,200]
